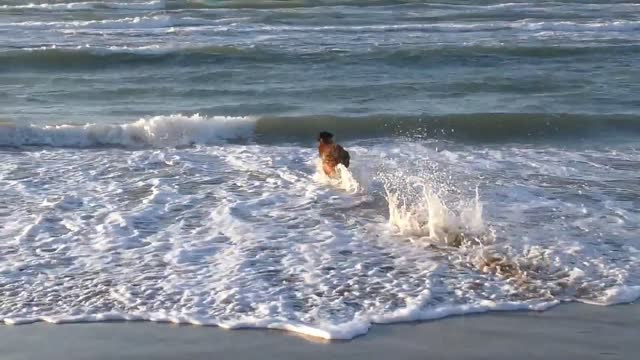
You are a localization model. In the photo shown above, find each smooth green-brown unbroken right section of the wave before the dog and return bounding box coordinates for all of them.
[255,113,640,142]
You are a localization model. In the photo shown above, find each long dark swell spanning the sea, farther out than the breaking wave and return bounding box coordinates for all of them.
[0,44,640,69]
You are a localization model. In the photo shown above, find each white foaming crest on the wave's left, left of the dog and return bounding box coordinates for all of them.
[0,114,256,147]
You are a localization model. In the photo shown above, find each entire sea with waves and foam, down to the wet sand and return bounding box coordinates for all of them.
[0,0,640,339]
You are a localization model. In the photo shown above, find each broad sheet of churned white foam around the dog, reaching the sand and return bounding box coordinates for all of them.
[0,139,640,339]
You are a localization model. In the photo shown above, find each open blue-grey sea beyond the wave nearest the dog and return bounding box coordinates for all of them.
[0,1,640,129]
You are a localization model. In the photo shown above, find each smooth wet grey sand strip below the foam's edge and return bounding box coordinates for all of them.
[0,304,640,360]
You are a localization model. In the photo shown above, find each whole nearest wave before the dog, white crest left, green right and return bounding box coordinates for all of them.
[0,113,640,148]
